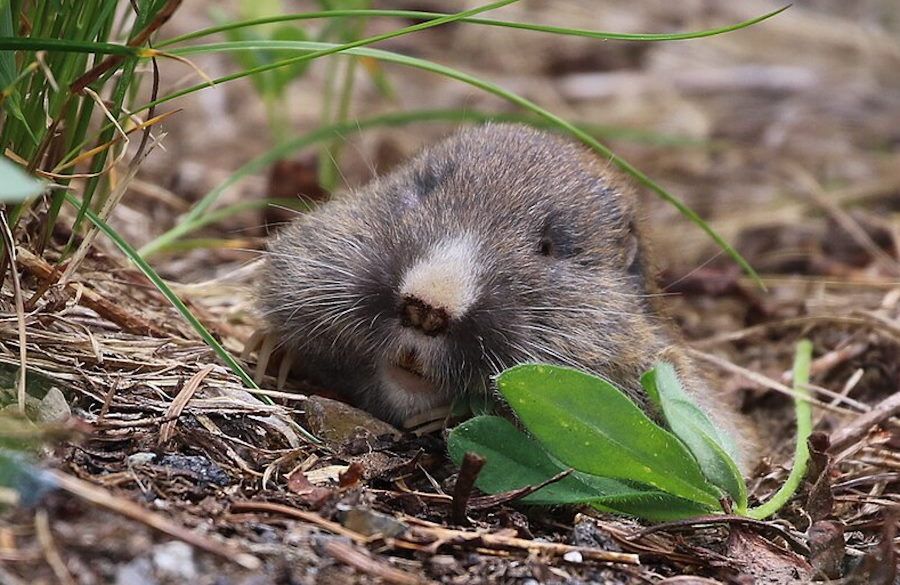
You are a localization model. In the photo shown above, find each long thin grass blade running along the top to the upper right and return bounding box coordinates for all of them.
[158,5,790,47]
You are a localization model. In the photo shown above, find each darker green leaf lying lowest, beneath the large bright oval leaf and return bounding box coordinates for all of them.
[447,416,713,521]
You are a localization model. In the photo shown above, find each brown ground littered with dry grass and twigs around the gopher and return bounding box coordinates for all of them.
[0,0,900,585]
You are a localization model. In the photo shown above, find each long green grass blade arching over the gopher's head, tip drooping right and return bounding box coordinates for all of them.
[162,41,765,288]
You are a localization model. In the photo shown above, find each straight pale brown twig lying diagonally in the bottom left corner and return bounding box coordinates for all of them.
[49,470,262,570]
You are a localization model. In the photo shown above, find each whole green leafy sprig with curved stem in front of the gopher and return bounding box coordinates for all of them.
[448,341,812,520]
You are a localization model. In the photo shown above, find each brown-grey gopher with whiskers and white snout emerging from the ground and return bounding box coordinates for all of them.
[259,124,752,466]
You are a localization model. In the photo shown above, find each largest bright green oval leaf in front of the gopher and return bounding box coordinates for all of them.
[497,364,719,507]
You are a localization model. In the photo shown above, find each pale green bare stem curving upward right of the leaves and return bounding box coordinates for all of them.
[747,339,812,520]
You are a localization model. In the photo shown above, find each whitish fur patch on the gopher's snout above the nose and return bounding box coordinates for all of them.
[400,234,479,319]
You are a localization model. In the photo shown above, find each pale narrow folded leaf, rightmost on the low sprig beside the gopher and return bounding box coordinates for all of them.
[641,362,747,513]
